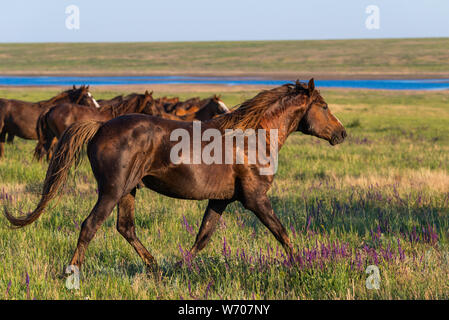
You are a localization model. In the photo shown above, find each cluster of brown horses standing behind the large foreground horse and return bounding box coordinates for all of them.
[0,86,229,160]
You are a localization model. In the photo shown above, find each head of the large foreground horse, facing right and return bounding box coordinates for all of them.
[298,79,347,145]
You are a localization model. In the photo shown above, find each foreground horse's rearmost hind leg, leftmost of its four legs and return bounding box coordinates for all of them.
[70,194,118,268]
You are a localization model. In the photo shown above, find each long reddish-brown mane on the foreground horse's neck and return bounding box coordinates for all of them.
[214,81,308,130]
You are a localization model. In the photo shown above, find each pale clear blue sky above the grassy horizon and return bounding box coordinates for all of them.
[0,0,449,42]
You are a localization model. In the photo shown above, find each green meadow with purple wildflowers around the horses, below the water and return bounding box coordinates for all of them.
[0,85,449,299]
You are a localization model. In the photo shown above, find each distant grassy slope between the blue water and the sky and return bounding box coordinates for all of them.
[0,38,449,78]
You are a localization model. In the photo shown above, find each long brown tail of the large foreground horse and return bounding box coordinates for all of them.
[4,120,103,228]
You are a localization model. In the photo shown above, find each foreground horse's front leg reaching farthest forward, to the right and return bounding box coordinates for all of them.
[241,194,293,259]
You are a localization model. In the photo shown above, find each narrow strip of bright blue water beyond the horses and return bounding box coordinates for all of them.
[0,76,449,90]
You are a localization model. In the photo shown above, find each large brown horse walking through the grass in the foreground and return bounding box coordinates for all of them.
[4,79,346,270]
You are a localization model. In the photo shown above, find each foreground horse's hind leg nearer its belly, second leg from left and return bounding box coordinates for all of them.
[117,188,157,272]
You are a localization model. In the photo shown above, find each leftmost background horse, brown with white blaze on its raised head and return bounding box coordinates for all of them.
[0,86,96,158]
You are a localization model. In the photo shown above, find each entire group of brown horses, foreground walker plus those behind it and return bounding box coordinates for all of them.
[0,79,347,271]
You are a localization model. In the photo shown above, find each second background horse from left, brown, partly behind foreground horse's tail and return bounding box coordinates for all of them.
[34,91,153,160]
